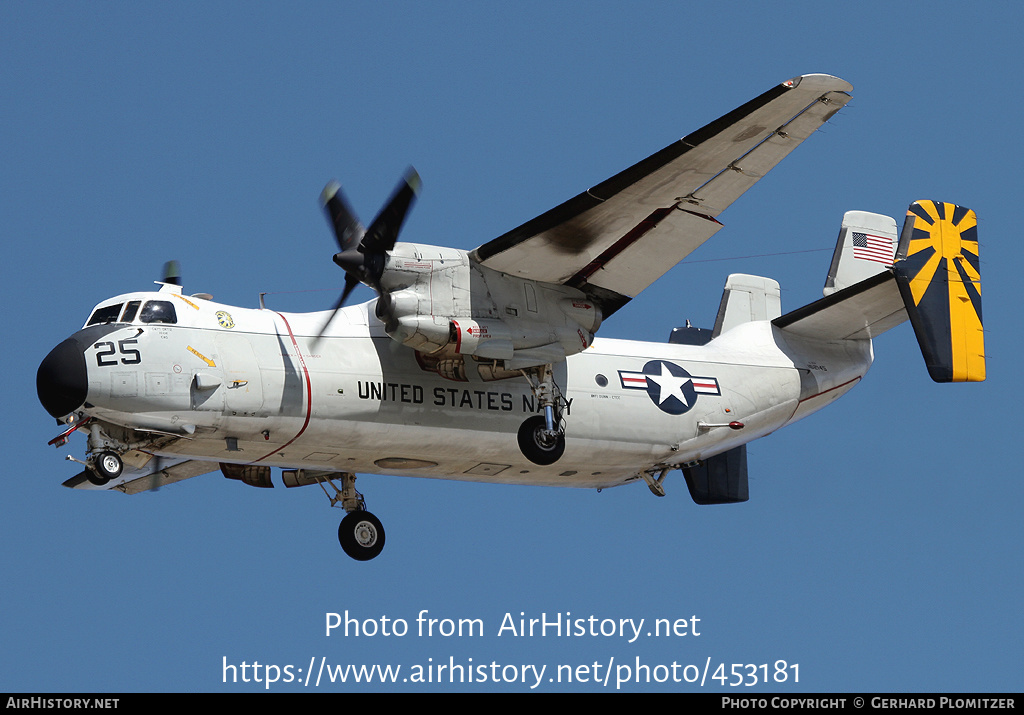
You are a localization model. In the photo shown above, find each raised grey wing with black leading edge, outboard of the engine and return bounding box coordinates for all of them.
[470,75,853,316]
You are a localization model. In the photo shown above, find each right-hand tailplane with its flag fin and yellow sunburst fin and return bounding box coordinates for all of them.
[772,201,985,382]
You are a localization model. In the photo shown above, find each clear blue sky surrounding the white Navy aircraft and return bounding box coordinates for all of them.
[0,2,1024,695]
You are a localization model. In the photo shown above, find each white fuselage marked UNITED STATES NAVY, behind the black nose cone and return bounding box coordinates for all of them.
[77,292,871,488]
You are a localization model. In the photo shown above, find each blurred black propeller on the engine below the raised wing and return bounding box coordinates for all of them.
[321,167,420,335]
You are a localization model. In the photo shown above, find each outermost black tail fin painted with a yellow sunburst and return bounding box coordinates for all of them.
[893,201,985,382]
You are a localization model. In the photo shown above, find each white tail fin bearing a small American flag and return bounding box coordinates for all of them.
[822,211,896,296]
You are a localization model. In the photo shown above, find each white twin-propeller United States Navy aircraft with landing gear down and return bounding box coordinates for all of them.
[37,75,985,560]
